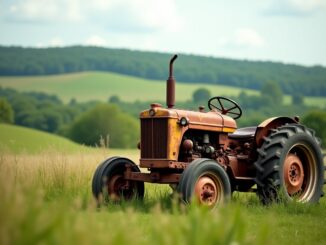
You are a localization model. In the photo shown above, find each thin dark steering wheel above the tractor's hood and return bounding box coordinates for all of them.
[208,96,242,119]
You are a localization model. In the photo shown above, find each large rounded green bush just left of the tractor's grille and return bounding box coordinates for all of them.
[69,104,139,148]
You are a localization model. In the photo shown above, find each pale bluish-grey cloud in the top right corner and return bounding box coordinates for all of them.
[265,0,326,16]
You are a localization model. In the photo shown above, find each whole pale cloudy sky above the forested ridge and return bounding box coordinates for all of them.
[0,0,326,66]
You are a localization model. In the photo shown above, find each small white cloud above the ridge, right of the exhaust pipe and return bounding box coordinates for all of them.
[235,28,265,47]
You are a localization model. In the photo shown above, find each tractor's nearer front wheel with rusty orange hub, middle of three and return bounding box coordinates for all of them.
[177,159,231,208]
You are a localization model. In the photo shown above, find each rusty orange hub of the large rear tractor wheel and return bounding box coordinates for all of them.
[284,153,304,195]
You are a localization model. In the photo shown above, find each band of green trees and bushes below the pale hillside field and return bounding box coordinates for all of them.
[0,83,326,148]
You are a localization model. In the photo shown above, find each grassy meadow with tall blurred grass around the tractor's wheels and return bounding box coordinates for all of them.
[0,124,326,244]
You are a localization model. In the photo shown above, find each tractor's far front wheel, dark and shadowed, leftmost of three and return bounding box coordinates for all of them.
[92,157,144,202]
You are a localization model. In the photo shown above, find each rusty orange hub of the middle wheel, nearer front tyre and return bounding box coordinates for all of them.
[195,176,218,206]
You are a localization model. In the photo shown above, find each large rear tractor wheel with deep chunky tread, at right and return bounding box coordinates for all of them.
[254,124,324,204]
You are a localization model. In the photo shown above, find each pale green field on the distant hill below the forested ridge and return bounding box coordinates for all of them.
[0,72,326,107]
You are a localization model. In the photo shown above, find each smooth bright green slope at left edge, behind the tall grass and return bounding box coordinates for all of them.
[0,124,91,153]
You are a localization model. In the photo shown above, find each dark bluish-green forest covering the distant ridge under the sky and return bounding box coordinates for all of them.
[0,46,326,96]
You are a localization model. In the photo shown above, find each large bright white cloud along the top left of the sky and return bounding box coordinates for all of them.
[3,0,182,32]
